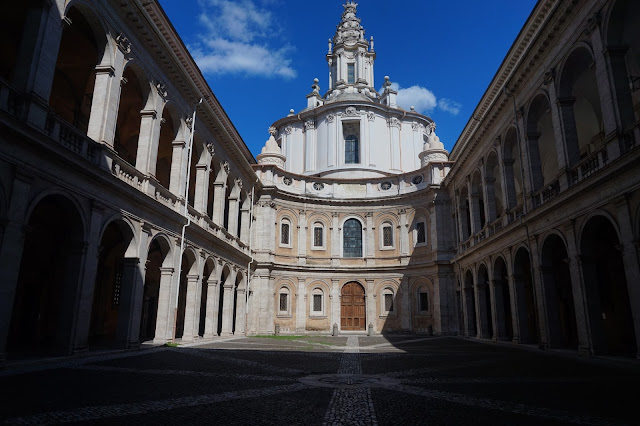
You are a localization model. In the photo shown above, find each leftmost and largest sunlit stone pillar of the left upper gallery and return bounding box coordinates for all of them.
[87,49,124,148]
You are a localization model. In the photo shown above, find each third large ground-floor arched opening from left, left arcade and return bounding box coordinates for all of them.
[140,238,172,342]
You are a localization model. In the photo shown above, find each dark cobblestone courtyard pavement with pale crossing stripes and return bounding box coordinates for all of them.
[0,335,640,425]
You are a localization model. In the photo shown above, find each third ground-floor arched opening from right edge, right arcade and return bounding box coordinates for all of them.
[513,247,540,343]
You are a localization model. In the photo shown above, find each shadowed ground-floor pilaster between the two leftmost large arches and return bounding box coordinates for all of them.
[73,202,104,353]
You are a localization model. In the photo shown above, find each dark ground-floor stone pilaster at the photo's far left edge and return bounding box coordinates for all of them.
[0,170,33,361]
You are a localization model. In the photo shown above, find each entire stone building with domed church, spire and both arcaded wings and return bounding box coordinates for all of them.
[0,0,640,357]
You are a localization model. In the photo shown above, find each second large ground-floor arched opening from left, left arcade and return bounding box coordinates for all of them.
[89,221,133,346]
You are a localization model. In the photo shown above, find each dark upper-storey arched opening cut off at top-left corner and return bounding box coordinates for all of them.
[0,1,32,80]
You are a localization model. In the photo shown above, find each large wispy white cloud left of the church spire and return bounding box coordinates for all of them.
[189,0,296,78]
